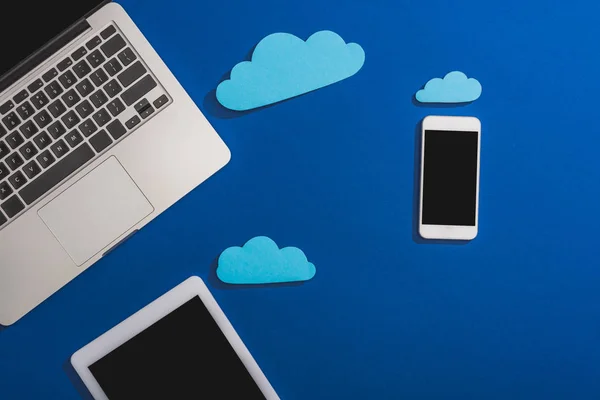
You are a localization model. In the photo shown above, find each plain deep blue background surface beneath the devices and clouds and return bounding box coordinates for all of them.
[0,0,600,400]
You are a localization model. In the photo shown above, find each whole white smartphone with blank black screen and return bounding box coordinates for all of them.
[419,116,481,240]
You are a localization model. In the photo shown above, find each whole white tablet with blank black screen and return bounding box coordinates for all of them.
[71,277,279,400]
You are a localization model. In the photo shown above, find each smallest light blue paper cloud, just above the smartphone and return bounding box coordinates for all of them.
[416,71,482,103]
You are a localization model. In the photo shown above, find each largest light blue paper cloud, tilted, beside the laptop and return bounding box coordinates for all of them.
[216,31,365,111]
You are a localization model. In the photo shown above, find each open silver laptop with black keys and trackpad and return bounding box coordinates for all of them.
[0,0,230,326]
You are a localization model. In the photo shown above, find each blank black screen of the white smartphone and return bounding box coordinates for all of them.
[422,130,479,226]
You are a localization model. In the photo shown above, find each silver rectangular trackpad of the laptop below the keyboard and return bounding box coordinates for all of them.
[38,157,154,265]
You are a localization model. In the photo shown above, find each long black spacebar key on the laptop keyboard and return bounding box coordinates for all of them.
[19,143,94,205]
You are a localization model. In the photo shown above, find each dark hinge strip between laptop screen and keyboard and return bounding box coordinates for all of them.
[0,0,111,93]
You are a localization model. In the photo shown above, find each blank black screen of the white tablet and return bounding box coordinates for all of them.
[90,296,265,400]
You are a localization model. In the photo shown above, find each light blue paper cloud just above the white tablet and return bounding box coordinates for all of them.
[217,236,316,285]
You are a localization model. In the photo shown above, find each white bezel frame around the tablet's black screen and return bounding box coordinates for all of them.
[71,276,279,400]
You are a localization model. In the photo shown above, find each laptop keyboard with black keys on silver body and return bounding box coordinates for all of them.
[0,25,170,229]
